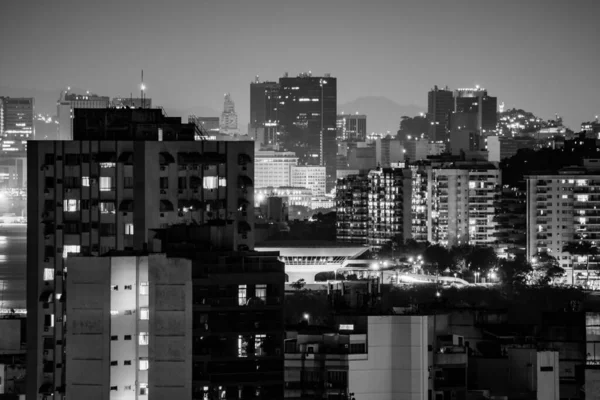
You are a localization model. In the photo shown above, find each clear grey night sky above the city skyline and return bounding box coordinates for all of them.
[0,0,600,128]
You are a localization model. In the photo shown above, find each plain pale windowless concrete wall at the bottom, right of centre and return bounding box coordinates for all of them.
[348,315,429,400]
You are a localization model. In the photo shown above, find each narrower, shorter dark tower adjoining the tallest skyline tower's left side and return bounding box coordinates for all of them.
[249,77,279,149]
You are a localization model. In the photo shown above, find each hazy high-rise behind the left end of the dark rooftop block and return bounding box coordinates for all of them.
[56,90,110,140]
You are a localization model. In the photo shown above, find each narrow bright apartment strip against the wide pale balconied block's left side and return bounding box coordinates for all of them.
[409,163,428,242]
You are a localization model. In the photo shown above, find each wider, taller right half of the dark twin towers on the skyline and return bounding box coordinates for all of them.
[279,73,337,192]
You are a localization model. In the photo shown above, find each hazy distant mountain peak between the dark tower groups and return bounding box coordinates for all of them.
[338,96,427,134]
